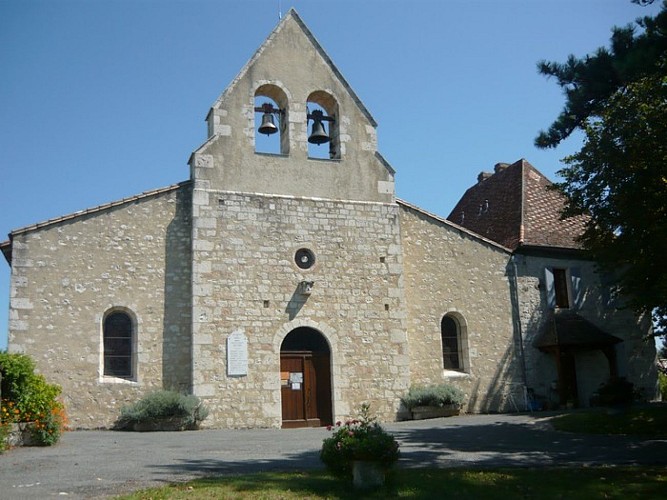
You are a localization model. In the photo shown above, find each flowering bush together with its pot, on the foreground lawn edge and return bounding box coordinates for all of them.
[320,403,399,489]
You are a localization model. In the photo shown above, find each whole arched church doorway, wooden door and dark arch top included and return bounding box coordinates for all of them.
[280,327,332,428]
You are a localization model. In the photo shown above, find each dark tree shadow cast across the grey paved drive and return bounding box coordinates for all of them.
[144,418,667,476]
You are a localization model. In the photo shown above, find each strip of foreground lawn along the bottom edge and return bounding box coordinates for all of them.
[119,467,667,500]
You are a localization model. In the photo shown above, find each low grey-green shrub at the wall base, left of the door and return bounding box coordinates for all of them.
[115,390,208,429]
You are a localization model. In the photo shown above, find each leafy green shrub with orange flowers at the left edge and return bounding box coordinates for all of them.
[0,352,67,446]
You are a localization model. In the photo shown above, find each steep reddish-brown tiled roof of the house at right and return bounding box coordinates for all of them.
[447,159,586,250]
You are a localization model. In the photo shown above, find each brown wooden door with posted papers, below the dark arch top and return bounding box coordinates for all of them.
[280,351,332,428]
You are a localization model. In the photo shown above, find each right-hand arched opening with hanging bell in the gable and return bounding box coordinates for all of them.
[307,90,341,160]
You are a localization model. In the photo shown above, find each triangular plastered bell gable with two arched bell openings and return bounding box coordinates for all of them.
[191,9,394,203]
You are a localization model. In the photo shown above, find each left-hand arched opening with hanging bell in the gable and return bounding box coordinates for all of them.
[254,84,289,155]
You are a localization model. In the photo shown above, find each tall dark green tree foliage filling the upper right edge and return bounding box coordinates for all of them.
[535,0,667,334]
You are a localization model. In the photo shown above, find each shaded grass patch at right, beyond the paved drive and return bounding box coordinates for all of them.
[551,405,667,439]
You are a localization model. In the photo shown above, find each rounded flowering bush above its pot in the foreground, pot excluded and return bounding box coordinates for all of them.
[320,403,399,476]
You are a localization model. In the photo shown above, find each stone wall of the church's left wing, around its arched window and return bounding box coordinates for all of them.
[9,186,191,428]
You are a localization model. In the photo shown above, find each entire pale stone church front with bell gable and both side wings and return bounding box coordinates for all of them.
[0,10,655,428]
